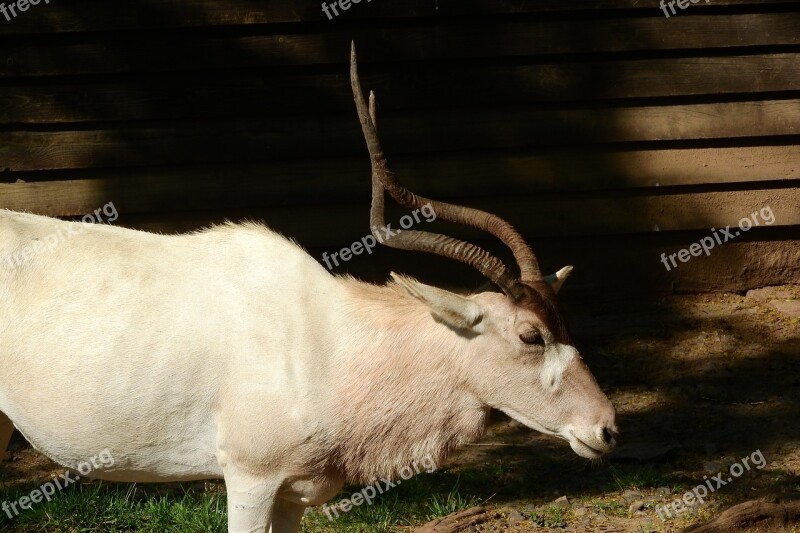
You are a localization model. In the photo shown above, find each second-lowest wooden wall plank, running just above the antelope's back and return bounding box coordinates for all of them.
[25,186,800,246]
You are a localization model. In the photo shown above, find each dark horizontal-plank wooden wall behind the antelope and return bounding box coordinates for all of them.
[0,0,800,292]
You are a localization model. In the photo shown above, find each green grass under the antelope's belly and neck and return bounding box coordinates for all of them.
[0,473,477,533]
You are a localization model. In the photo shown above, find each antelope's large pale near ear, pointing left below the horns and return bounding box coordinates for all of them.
[392,272,483,333]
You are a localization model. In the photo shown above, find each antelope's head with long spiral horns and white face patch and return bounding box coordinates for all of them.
[350,45,617,459]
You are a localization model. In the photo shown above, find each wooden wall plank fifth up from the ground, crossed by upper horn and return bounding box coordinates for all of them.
[0,54,800,124]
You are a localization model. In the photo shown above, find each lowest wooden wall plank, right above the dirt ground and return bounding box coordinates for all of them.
[309,234,800,294]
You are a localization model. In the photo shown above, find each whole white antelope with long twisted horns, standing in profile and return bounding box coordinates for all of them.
[0,47,617,533]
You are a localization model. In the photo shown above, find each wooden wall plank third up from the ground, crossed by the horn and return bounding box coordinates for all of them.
[0,146,800,216]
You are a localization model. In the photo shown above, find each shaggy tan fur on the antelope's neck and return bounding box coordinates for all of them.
[324,279,488,482]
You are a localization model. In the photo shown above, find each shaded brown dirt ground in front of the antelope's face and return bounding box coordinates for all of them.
[7,286,800,532]
